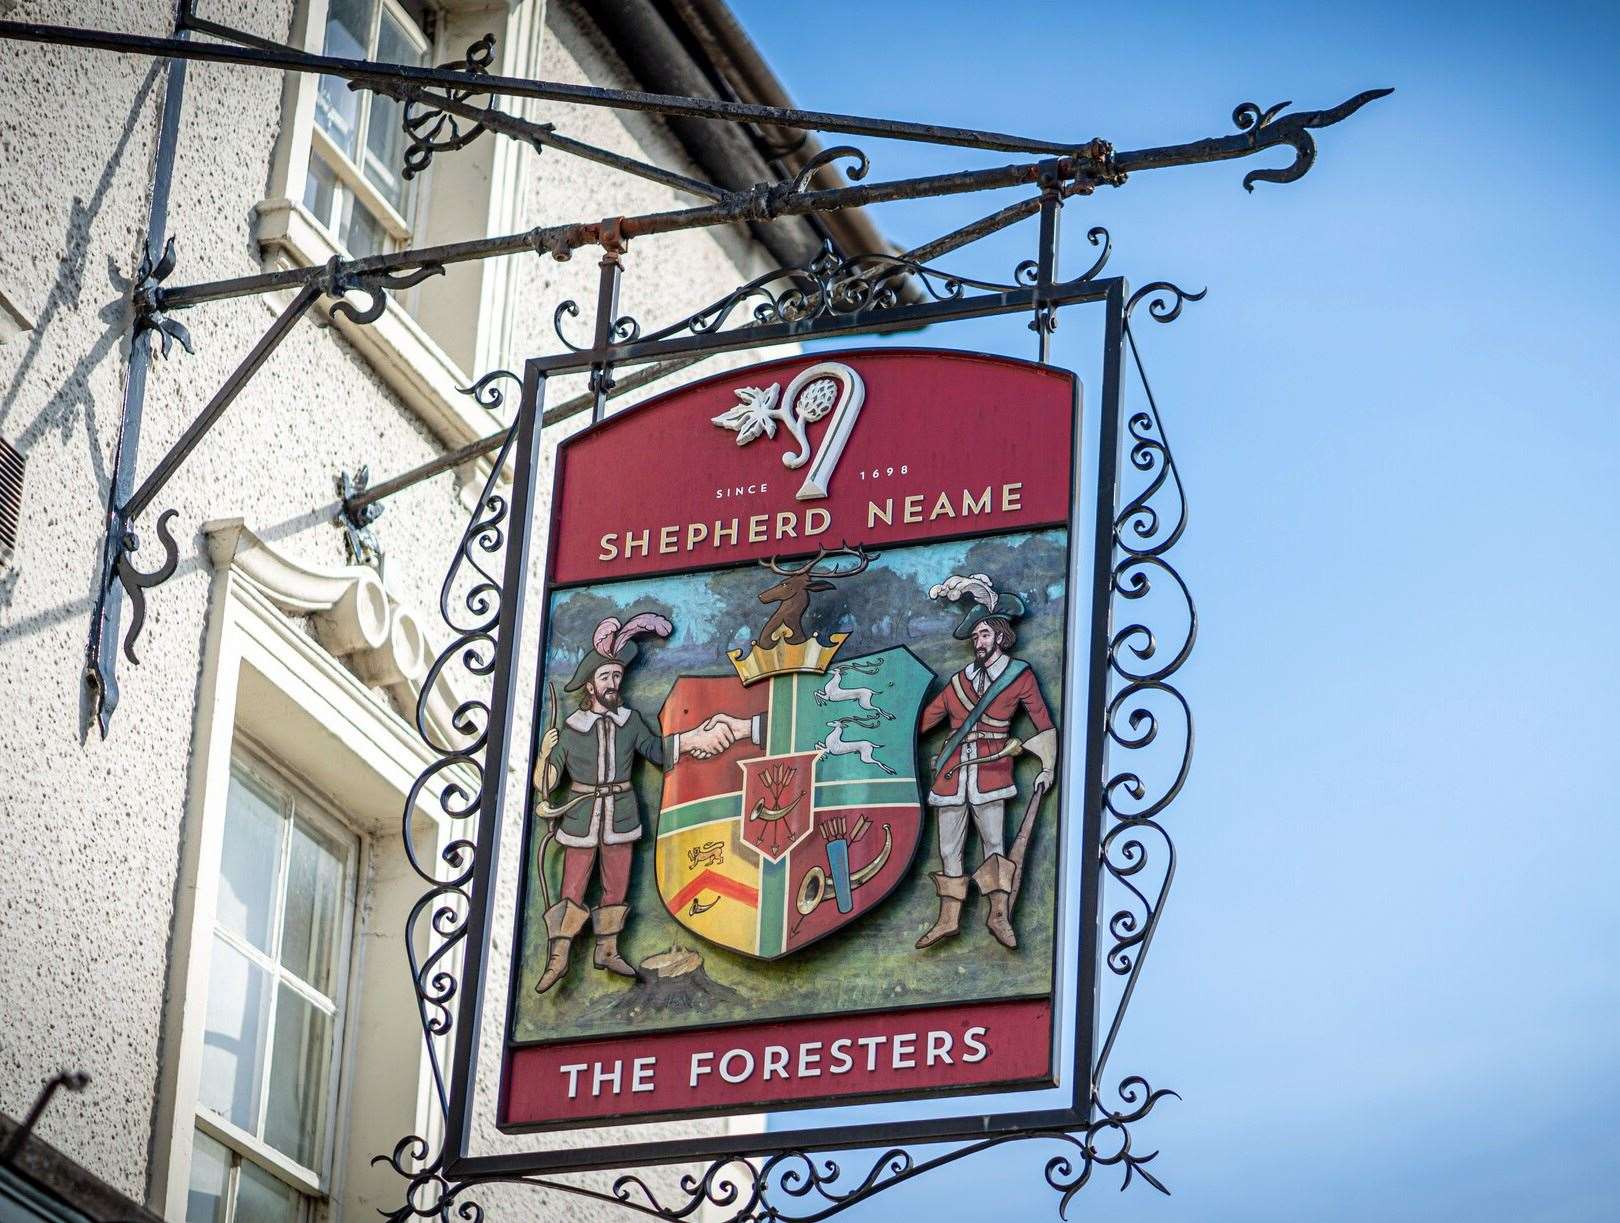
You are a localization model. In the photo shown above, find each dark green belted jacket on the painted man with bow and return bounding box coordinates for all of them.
[546,705,672,849]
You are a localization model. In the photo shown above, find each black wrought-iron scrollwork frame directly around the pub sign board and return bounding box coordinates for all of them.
[385,257,1202,1218]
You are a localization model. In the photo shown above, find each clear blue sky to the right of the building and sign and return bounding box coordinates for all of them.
[735,0,1620,1223]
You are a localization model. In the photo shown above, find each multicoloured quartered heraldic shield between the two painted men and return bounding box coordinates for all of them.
[656,646,932,959]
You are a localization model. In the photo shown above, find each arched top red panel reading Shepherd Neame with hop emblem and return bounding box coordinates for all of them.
[551,350,1074,583]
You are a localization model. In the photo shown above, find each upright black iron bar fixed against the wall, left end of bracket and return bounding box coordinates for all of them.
[84,0,191,739]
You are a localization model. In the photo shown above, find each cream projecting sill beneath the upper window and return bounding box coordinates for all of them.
[256,199,507,460]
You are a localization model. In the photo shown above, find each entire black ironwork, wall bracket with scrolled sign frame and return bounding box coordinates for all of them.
[0,0,1392,1223]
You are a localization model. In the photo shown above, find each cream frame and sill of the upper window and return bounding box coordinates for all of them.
[256,0,544,453]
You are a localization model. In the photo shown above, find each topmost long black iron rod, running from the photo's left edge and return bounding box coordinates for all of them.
[0,21,1072,156]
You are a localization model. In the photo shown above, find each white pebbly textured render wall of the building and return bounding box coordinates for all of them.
[0,0,784,1217]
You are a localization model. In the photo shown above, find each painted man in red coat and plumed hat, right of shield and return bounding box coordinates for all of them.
[917,573,1058,948]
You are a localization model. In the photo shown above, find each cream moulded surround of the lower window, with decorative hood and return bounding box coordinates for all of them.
[149,520,454,1220]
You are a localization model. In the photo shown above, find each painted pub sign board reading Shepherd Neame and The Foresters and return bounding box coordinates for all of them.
[501,350,1081,1129]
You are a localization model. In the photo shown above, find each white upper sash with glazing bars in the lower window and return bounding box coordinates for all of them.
[196,745,368,1197]
